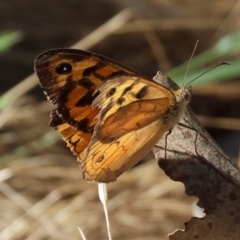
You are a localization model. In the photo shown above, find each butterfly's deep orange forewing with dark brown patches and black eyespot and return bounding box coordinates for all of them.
[35,50,136,133]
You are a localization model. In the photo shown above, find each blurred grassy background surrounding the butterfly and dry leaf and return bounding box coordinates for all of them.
[0,0,240,240]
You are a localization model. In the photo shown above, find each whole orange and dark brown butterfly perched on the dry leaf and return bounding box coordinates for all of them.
[34,49,191,183]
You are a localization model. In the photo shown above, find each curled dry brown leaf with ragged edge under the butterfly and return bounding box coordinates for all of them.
[153,72,240,240]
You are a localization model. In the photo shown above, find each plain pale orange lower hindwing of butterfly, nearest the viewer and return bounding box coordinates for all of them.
[81,107,173,182]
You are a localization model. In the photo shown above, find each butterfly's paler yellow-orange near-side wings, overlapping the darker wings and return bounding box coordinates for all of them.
[81,76,175,182]
